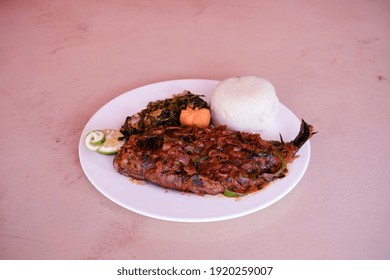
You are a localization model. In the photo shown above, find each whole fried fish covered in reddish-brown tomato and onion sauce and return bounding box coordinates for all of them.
[114,120,315,196]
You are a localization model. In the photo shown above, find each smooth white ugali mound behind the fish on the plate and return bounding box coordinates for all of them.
[210,76,279,133]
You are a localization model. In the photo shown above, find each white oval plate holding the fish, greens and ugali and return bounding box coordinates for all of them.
[79,79,310,222]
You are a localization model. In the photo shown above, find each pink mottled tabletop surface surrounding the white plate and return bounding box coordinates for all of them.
[0,0,390,259]
